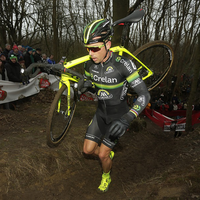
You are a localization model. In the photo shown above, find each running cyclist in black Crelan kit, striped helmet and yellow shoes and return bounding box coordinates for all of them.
[83,19,150,192]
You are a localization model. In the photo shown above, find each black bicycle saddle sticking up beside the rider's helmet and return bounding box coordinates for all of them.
[113,9,144,26]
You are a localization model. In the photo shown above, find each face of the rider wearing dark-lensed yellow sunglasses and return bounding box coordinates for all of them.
[87,41,111,63]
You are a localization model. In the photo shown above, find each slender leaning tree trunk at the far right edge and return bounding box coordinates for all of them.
[186,33,200,132]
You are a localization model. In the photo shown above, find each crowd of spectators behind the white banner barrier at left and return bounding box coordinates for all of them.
[0,44,55,82]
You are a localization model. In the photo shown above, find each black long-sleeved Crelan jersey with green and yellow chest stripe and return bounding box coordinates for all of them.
[85,52,150,120]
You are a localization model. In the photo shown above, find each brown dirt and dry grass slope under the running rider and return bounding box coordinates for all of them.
[0,90,200,200]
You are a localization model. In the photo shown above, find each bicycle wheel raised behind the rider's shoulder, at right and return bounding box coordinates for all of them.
[133,41,174,91]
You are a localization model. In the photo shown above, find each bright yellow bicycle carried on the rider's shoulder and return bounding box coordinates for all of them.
[26,9,174,147]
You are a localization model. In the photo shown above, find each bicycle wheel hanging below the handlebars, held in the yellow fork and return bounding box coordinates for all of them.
[46,85,77,147]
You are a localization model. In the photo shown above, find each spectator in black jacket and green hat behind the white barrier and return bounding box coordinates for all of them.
[5,55,22,82]
